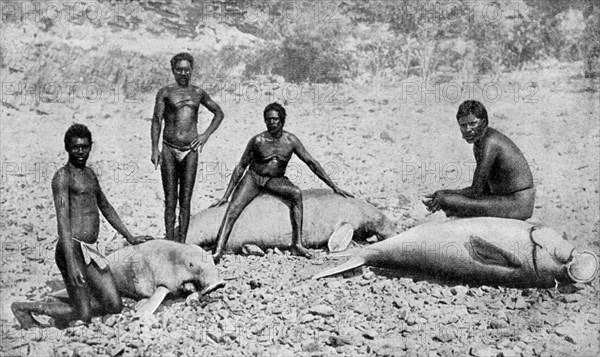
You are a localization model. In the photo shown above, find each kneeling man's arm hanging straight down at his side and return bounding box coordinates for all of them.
[52,169,85,286]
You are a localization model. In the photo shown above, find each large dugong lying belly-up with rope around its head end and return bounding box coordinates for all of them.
[313,217,598,287]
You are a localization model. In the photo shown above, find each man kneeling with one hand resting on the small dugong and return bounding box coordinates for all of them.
[11,124,151,329]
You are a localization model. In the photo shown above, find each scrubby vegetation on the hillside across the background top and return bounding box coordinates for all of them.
[1,0,600,101]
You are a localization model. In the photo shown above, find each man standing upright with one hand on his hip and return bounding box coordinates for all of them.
[151,53,223,242]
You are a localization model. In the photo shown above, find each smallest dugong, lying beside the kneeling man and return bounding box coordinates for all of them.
[106,239,225,315]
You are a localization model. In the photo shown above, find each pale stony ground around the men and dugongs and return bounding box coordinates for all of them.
[0,64,600,356]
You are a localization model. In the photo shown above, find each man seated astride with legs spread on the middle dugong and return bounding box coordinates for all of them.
[213,103,352,262]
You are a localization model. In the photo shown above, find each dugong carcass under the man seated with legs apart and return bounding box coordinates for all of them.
[186,190,396,253]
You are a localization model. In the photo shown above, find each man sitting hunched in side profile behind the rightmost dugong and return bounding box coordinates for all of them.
[423,100,535,220]
